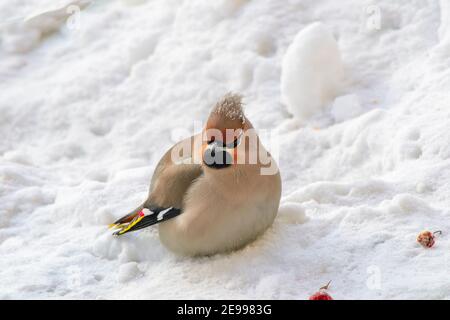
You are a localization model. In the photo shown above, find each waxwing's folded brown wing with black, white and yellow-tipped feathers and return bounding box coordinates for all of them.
[110,136,203,235]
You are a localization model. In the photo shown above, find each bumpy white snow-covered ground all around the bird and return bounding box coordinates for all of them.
[0,0,450,299]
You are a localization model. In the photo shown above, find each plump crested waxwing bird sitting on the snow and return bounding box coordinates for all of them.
[112,94,281,256]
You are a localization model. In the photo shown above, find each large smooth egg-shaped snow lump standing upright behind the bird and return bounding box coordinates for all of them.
[281,22,344,120]
